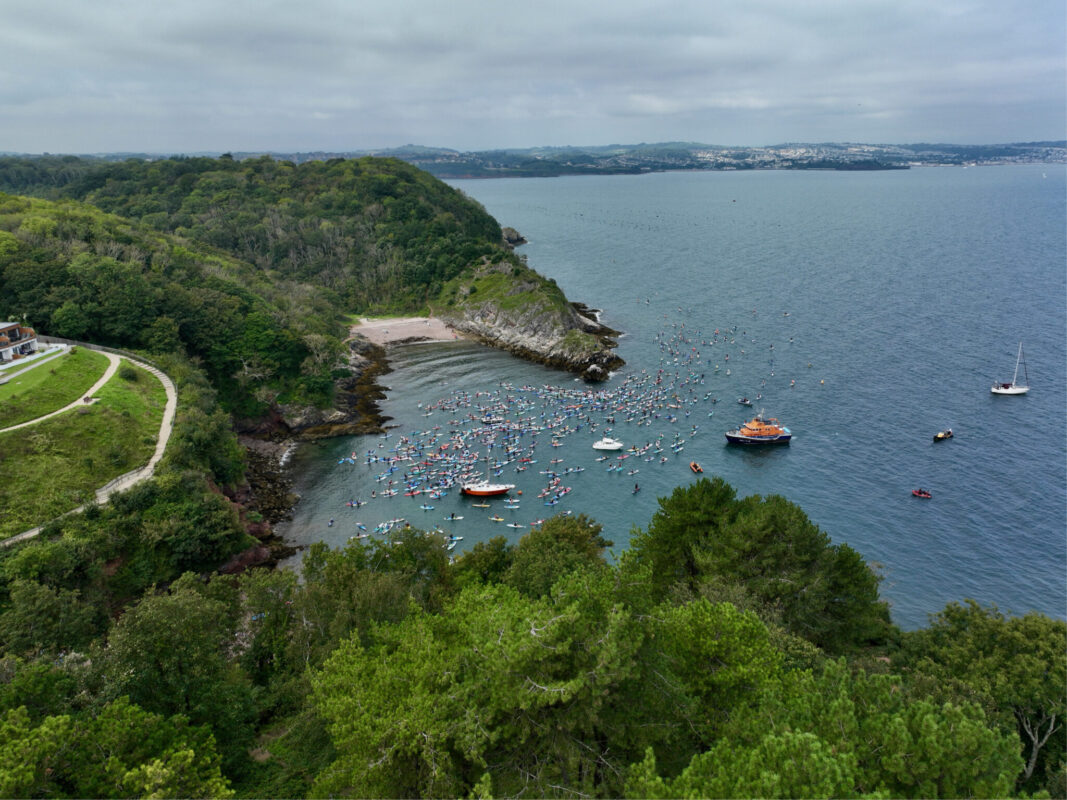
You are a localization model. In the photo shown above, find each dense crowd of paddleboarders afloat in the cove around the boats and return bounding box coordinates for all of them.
[331,309,810,549]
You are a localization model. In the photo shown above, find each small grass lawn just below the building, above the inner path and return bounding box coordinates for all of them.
[0,348,108,428]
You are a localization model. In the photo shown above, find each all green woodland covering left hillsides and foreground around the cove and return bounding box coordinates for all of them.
[0,158,1067,798]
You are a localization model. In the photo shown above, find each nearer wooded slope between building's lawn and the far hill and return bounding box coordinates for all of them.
[0,189,344,415]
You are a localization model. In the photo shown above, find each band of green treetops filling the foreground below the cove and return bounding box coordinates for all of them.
[0,476,1067,798]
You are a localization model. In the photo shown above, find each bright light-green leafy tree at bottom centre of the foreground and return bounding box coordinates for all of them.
[315,587,638,797]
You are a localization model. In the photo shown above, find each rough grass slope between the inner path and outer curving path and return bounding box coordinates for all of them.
[0,362,166,538]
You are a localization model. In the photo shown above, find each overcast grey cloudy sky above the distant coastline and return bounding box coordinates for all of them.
[0,0,1067,155]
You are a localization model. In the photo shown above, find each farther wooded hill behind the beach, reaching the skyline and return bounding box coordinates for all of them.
[0,157,510,310]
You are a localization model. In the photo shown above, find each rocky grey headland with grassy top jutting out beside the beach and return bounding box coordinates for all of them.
[433,262,623,381]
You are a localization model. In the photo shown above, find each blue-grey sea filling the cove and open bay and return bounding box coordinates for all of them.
[280,164,1067,629]
